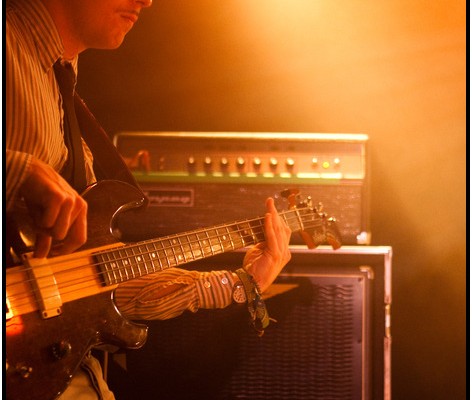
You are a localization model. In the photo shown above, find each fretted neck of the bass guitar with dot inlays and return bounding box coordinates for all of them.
[94,210,303,286]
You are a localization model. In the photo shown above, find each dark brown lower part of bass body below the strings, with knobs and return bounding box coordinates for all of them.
[5,292,147,400]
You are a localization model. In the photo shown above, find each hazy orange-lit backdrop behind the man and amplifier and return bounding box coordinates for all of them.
[79,0,467,400]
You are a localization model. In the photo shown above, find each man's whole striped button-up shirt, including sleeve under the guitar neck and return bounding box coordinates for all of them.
[5,0,236,319]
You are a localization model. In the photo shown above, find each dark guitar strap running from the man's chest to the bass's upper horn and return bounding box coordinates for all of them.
[74,93,145,192]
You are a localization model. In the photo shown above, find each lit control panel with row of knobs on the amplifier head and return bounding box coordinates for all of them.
[114,132,367,179]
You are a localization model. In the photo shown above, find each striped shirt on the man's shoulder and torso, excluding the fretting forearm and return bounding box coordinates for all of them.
[5,0,95,210]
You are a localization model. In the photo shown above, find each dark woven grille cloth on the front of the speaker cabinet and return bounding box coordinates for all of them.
[112,276,364,400]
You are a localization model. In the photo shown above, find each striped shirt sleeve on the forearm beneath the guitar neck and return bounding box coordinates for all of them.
[114,268,236,320]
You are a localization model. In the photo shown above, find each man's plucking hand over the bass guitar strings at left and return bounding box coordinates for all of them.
[20,159,87,257]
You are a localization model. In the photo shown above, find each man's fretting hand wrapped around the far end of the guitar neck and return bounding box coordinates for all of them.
[243,198,291,292]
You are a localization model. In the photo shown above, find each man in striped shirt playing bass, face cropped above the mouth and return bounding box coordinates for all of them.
[5,0,290,399]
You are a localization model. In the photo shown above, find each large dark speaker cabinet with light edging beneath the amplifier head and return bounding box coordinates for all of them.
[108,246,392,400]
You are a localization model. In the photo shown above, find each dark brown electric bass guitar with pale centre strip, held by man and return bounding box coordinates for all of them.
[4,181,341,400]
